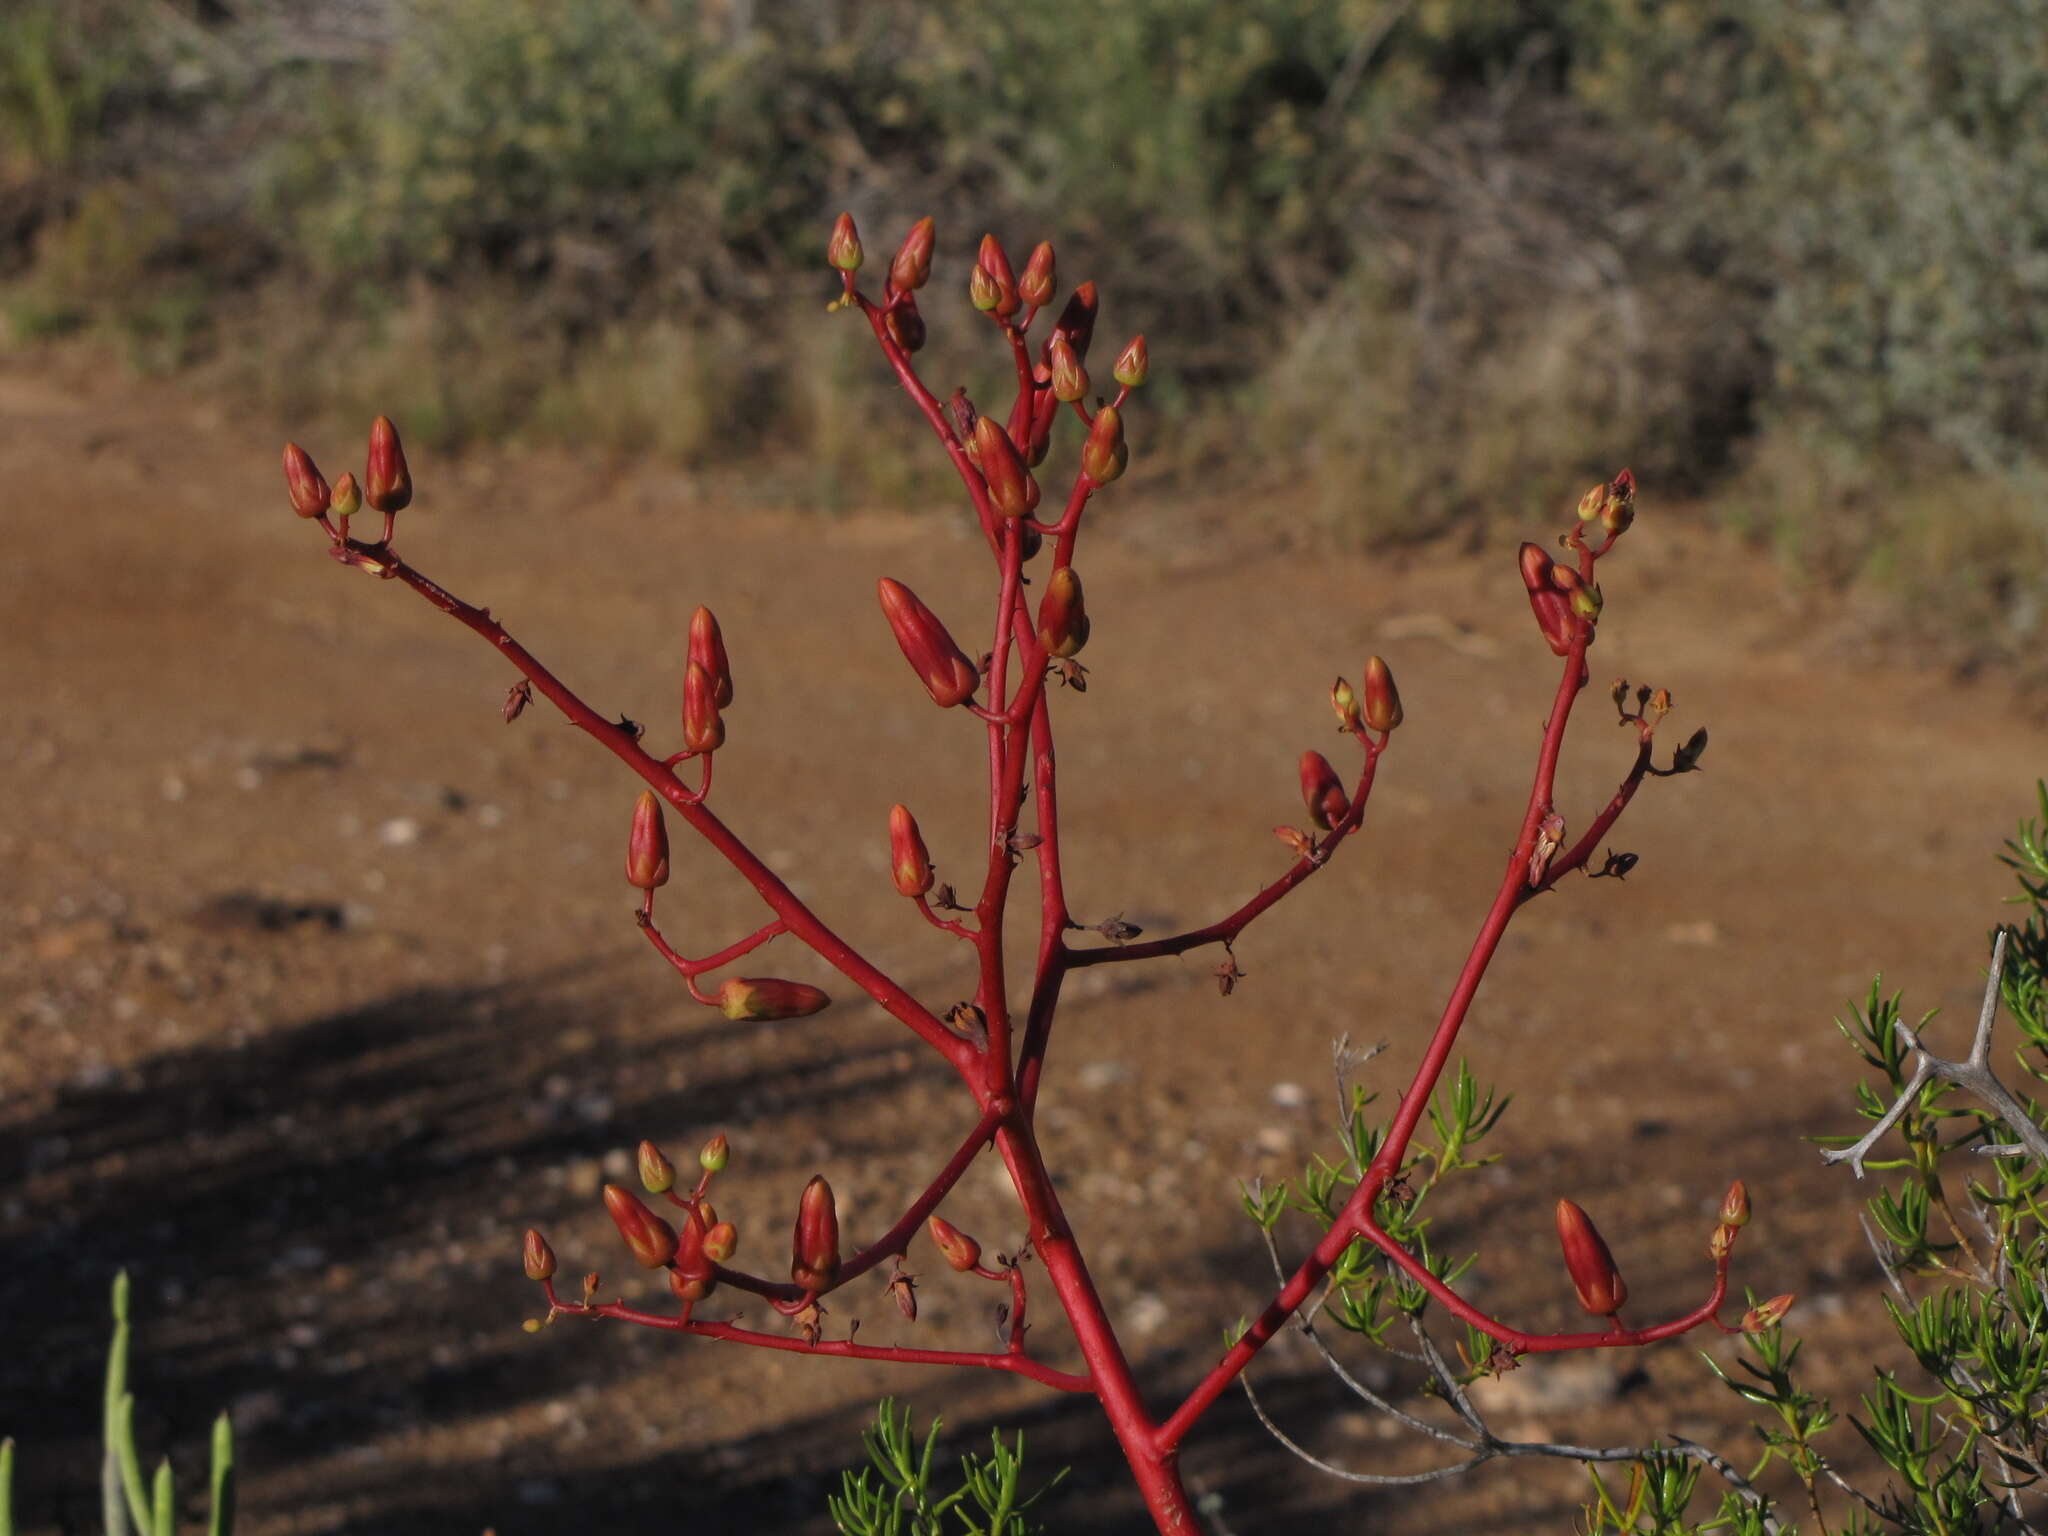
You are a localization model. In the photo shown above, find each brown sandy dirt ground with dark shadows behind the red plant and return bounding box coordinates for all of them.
[0,373,2048,1536]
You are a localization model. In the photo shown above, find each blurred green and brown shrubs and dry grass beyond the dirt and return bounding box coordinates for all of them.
[0,0,2048,653]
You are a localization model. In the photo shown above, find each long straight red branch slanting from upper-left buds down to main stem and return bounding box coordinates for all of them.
[366,545,975,1077]
